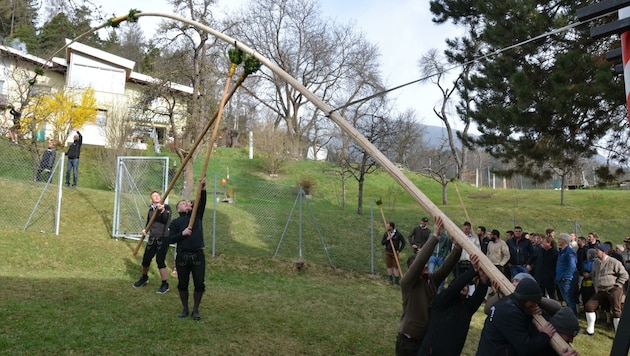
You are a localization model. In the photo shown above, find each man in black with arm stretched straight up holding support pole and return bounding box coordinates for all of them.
[168,178,206,320]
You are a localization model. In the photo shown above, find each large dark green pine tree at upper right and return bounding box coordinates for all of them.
[431,0,625,204]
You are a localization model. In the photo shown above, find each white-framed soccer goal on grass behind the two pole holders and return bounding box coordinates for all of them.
[112,156,169,240]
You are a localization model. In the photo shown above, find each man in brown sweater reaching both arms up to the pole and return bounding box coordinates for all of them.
[396,217,462,356]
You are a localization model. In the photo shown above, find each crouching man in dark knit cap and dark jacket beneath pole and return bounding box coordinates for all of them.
[477,278,555,356]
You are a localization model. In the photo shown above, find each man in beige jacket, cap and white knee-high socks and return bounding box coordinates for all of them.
[584,244,628,335]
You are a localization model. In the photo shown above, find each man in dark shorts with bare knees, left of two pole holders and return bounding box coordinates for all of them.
[133,191,171,294]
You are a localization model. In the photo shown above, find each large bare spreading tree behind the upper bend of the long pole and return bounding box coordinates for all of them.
[228,0,380,157]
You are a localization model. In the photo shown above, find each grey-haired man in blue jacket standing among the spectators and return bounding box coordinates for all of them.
[556,233,577,315]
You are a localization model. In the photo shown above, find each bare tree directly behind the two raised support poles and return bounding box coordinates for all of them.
[148,0,229,197]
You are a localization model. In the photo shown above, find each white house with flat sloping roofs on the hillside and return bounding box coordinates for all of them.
[0,40,193,148]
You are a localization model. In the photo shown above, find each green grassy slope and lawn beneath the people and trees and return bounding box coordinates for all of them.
[0,140,630,355]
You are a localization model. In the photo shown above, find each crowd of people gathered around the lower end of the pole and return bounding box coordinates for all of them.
[382,217,630,355]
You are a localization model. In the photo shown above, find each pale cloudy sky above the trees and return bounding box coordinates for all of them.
[101,0,461,128]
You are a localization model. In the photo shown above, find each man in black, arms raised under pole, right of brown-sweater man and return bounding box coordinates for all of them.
[418,255,488,355]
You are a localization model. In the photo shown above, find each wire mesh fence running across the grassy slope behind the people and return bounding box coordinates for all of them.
[0,141,630,273]
